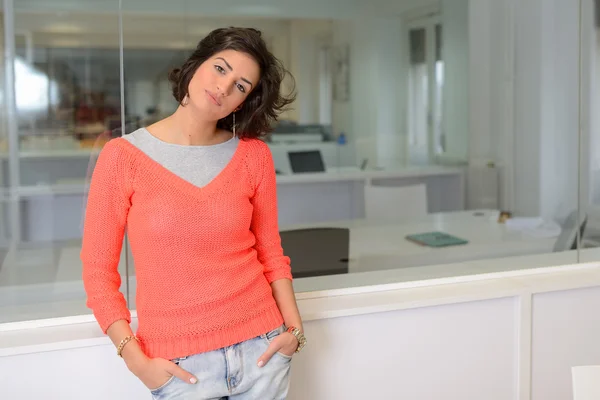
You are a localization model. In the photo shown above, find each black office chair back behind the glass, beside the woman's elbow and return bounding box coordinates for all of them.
[279,228,350,278]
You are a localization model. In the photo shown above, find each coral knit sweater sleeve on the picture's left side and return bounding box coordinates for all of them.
[80,139,132,333]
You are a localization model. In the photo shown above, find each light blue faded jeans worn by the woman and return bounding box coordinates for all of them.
[152,326,292,400]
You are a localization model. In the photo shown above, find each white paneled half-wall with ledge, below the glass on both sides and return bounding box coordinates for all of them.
[0,252,600,400]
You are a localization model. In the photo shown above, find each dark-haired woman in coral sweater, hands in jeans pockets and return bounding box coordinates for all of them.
[81,28,305,400]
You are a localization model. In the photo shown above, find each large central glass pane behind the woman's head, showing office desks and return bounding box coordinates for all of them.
[116,0,578,296]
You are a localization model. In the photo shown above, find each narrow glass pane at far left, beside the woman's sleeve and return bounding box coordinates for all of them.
[0,0,125,322]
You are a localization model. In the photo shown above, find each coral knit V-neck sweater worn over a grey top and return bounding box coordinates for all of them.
[81,138,292,359]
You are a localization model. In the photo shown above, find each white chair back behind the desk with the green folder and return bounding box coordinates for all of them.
[365,183,427,222]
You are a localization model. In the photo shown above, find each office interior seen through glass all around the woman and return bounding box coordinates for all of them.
[0,0,600,399]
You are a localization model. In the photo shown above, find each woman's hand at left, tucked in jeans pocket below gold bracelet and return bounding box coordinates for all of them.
[128,357,198,390]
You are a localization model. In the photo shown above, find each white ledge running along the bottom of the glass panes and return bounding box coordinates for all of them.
[0,250,600,357]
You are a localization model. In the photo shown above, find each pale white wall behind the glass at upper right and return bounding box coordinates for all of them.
[469,0,579,218]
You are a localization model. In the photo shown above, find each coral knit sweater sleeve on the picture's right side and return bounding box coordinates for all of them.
[251,142,292,283]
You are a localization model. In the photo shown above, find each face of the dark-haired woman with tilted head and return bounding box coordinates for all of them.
[188,50,260,120]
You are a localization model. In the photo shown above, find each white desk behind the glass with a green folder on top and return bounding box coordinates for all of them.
[281,210,556,273]
